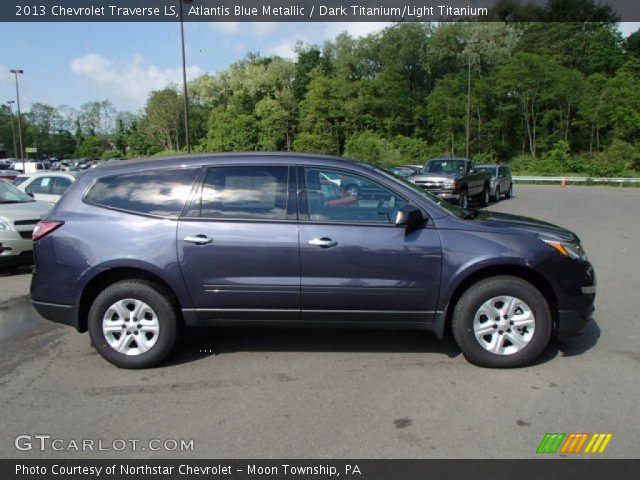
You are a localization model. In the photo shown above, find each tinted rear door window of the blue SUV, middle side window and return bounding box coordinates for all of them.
[188,166,289,220]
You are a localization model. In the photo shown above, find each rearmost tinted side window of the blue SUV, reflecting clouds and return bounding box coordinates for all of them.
[84,168,199,217]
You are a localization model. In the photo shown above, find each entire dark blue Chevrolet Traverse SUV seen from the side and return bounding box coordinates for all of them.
[31,153,595,368]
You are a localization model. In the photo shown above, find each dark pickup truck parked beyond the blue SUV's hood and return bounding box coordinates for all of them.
[411,158,491,208]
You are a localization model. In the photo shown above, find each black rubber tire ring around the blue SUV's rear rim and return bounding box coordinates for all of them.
[88,280,179,369]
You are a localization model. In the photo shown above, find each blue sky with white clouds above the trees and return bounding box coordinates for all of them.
[0,22,640,112]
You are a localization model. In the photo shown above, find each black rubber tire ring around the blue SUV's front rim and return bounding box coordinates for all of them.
[451,276,553,368]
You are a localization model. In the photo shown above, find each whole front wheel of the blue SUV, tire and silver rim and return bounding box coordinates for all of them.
[452,276,552,368]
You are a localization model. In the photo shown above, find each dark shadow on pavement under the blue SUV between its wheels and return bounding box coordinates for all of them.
[165,327,460,366]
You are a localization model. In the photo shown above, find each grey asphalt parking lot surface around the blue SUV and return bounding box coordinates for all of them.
[0,186,640,458]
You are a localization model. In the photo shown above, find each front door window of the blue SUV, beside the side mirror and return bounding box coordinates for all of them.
[305,168,407,224]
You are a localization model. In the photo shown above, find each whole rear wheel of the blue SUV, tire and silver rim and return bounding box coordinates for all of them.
[88,280,178,368]
